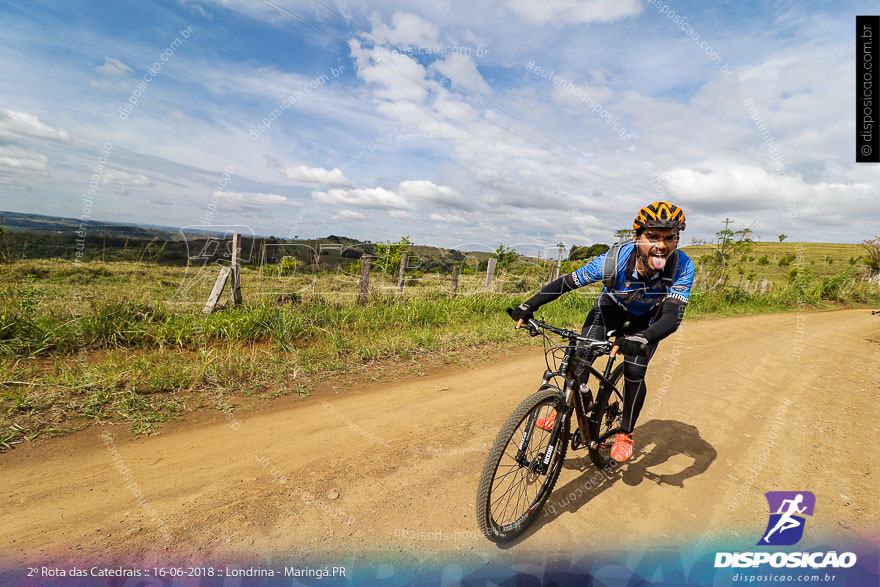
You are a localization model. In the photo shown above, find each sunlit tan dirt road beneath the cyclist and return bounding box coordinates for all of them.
[0,310,880,564]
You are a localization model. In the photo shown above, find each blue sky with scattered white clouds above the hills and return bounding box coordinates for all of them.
[0,0,880,252]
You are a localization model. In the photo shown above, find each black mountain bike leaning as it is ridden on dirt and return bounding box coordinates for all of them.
[476,310,623,543]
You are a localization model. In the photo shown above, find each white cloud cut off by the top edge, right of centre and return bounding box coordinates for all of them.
[507,0,642,25]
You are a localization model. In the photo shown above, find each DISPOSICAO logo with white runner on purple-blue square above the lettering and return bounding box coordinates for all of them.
[715,491,857,569]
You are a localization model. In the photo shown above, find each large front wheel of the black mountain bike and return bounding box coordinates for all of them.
[477,385,569,542]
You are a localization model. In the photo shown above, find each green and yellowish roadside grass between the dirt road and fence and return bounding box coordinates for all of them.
[0,254,880,450]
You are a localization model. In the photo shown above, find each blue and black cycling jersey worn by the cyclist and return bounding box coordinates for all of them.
[571,243,694,316]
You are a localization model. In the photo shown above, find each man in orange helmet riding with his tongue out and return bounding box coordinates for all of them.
[511,202,694,463]
